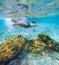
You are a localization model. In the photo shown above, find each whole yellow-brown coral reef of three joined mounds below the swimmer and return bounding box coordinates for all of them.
[0,34,59,65]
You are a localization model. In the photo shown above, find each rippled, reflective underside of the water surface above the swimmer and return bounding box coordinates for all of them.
[0,0,59,18]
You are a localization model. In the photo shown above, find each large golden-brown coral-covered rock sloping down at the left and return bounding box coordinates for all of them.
[0,36,26,65]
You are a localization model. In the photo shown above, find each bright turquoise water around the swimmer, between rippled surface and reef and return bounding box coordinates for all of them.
[0,15,59,44]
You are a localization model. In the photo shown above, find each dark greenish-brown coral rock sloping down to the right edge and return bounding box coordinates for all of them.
[38,34,59,52]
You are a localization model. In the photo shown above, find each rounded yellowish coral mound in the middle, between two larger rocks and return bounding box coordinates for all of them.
[25,39,46,53]
